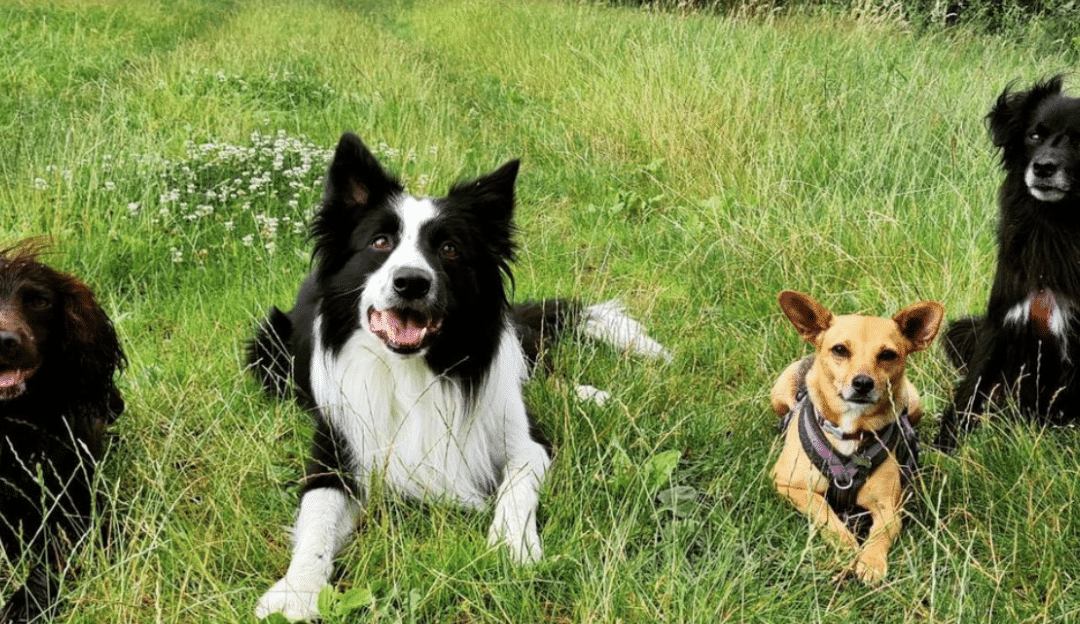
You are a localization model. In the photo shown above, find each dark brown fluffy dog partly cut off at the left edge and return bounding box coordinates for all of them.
[0,244,124,624]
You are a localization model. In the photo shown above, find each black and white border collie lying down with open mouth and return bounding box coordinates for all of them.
[248,134,670,620]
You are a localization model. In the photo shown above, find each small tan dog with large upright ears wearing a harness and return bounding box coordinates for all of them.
[770,290,945,582]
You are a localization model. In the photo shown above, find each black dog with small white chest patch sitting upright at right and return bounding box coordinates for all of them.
[934,76,1080,450]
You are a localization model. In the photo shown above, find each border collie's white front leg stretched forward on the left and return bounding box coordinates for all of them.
[255,488,360,622]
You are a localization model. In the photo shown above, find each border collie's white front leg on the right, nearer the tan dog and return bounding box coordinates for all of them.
[487,439,551,565]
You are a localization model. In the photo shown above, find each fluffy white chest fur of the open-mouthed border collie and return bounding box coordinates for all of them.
[311,316,528,507]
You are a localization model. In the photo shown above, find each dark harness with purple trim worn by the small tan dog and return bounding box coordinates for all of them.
[780,386,920,516]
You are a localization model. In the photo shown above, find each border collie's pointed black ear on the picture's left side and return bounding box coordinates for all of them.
[323,132,403,206]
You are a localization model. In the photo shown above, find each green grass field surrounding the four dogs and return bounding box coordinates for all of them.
[0,0,1080,623]
